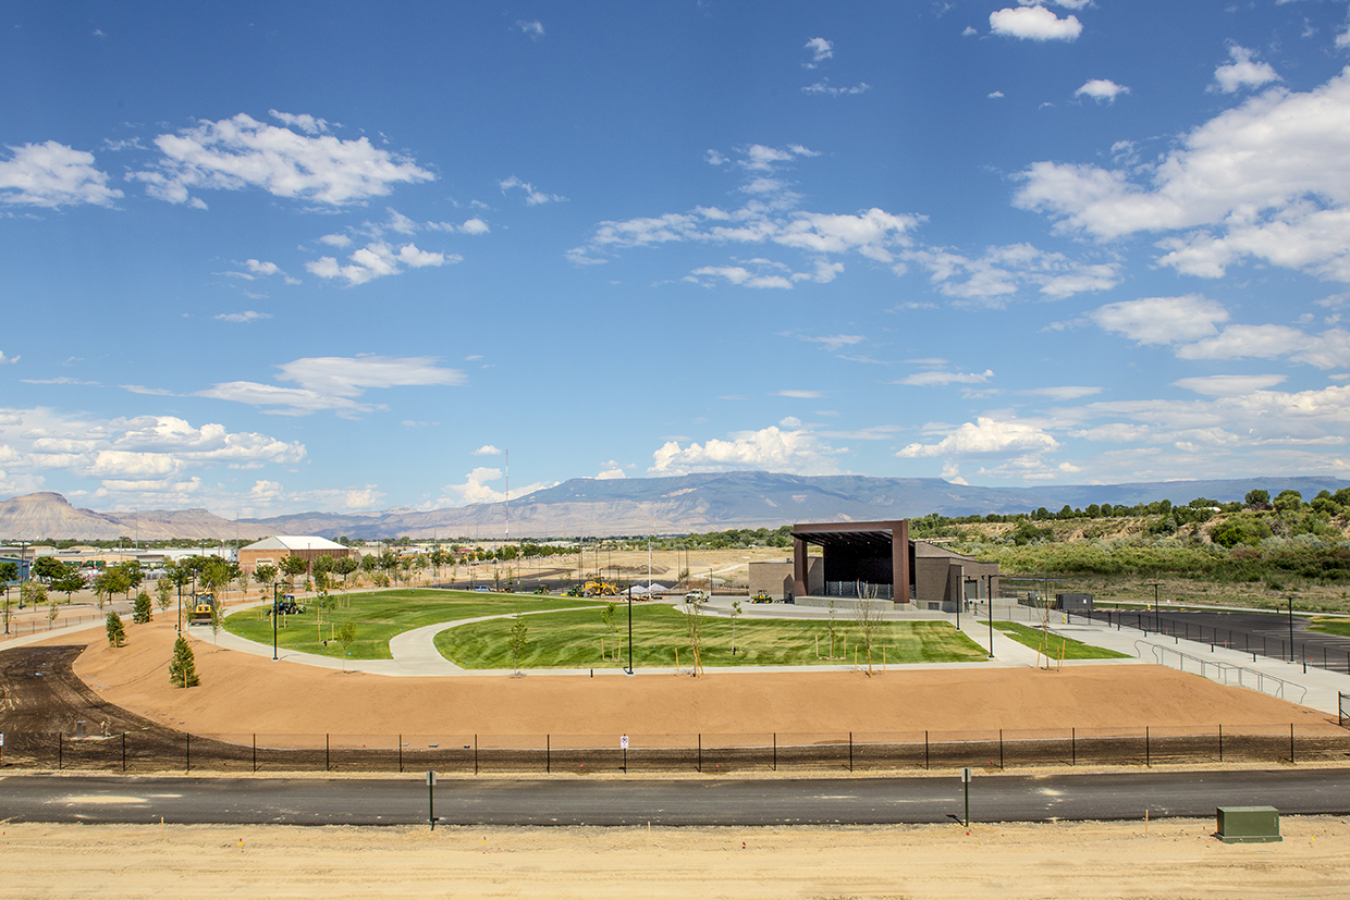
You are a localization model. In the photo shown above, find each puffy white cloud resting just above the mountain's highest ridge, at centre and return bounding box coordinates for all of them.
[647,425,844,475]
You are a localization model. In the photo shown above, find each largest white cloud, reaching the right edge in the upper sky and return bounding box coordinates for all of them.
[1014,70,1350,281]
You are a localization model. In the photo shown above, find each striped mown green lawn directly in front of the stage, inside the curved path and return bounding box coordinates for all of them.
[436,604,986,669]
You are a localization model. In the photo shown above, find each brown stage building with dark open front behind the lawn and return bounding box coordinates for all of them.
[749,519,999,613]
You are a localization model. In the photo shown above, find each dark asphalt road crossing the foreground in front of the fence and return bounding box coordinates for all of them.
[0,769,1350,826]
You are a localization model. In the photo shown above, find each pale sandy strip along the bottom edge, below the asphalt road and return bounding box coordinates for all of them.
[0,816,1350,900]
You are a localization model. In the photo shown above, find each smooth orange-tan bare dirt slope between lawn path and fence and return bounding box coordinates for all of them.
[65,621,1338,739]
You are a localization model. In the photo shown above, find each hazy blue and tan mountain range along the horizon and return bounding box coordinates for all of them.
[0,472,1346,541]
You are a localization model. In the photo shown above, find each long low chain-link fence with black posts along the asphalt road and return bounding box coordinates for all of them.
[0,723,1350,775]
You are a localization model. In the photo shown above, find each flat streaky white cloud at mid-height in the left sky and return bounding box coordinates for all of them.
[198,356,464,417]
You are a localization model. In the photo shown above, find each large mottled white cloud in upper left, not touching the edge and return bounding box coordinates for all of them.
[128,113,435,206]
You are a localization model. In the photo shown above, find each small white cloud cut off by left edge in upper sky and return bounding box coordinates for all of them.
[0,140,123,209]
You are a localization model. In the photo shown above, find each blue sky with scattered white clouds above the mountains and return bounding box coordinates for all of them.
[0,0,1350,515]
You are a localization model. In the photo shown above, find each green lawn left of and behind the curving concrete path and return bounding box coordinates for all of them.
[225,588,599,660]
